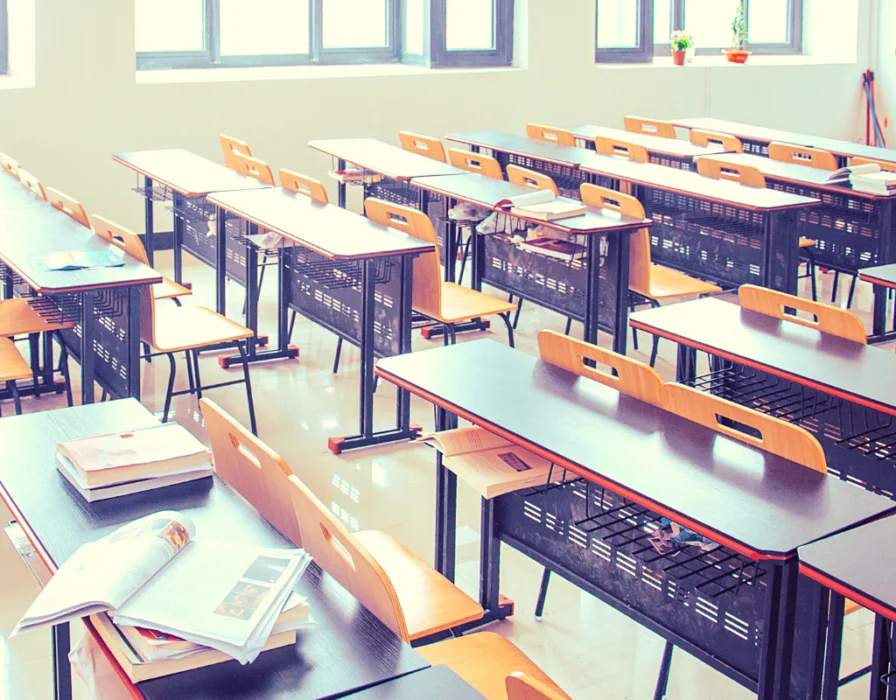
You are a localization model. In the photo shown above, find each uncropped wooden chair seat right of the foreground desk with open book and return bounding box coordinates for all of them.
[355,530,483,640]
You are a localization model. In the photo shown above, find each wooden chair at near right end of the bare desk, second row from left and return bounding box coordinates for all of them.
[364,198,516,347]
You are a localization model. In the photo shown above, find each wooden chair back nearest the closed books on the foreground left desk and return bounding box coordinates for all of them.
[199,398,302,547]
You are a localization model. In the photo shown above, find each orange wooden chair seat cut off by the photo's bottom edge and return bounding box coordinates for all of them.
[416,632,569,700]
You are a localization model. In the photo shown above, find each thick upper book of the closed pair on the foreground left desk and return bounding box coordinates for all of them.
[56,423,211,489]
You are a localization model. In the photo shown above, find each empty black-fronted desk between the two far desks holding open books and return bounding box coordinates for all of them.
[580,153,819,294]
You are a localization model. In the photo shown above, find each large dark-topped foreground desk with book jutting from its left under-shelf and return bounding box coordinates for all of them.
[377,340,896,698]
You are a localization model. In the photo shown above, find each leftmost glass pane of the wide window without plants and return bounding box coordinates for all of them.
[134,0,205,52]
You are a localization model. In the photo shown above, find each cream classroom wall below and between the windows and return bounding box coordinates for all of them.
[0,0,876,230]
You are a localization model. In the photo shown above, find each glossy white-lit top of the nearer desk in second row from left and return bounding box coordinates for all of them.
[208,187,435,260]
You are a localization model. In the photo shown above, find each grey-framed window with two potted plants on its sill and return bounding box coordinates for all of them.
[596,0,804,62]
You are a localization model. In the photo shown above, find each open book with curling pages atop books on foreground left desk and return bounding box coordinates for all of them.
[13,511,310,663]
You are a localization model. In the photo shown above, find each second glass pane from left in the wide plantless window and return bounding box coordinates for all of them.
[220,0,309,56]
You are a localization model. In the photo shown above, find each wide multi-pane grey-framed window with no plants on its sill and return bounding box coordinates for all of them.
[133,0,513,70]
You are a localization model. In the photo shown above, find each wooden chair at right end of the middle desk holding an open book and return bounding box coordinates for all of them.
[579,183,722,367]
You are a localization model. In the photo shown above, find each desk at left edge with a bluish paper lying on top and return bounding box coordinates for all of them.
[0,202,162,403]
